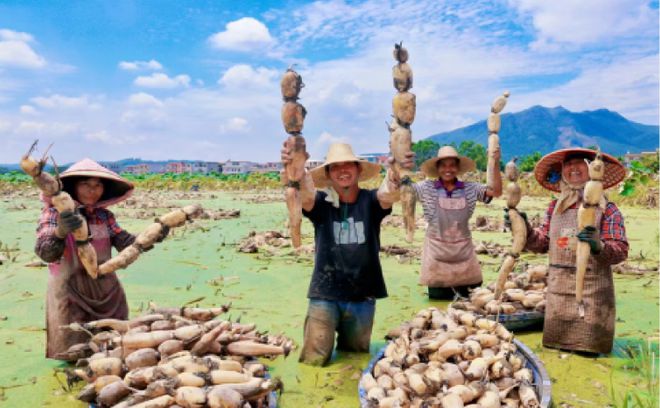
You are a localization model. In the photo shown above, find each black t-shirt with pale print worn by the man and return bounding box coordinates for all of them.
[303,189,392,301]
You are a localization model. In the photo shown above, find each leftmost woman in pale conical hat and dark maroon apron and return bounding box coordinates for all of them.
[35,159,166,359]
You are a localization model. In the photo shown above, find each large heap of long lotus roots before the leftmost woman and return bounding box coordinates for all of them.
[57,306,293,408]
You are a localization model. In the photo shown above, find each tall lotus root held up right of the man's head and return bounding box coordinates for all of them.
[388,43,416,242]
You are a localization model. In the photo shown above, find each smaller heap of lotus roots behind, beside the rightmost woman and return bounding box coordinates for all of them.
[452,265,548,315]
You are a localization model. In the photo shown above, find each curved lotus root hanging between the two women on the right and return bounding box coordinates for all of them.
[495,157,527,301]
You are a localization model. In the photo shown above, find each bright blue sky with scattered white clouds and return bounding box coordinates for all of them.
[0,0,660,163]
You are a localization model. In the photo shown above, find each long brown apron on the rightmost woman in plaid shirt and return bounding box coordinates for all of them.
[543,207,615,353]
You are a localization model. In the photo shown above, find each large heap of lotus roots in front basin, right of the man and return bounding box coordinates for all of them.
[360,308,539,408]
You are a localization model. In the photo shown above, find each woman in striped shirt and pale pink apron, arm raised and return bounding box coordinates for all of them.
[413,146,502,300]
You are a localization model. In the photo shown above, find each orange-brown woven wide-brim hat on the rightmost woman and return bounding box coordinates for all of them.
[534,147,626,192]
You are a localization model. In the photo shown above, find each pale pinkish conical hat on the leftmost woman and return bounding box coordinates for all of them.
[60,158,135,206]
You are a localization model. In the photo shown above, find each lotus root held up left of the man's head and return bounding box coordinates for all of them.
[281,68,309,248]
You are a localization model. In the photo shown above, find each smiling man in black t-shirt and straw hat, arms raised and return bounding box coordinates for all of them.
[282,143,413,365]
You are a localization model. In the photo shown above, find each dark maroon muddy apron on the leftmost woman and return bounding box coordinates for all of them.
[46,223,128,358]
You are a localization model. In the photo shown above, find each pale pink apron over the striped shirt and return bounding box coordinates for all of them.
[420,188,482,288]
